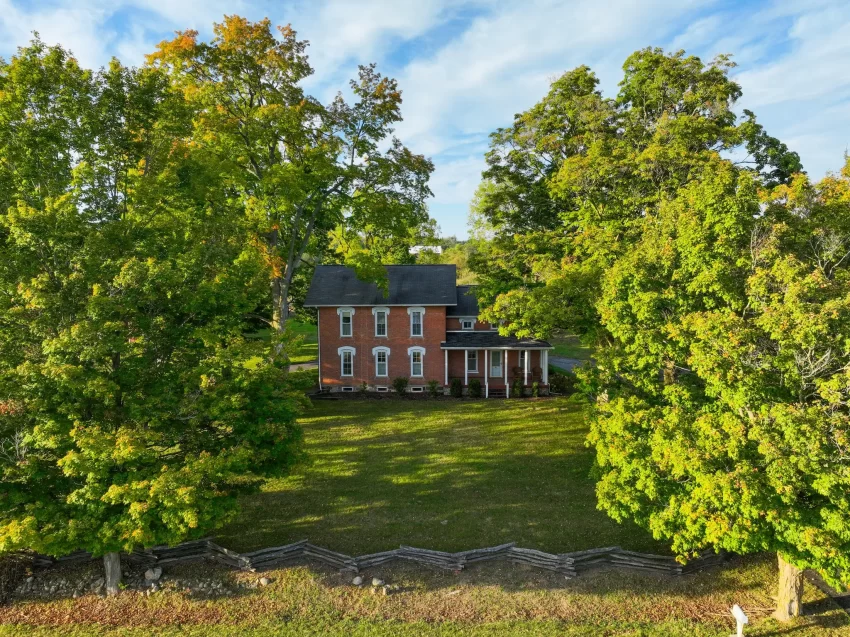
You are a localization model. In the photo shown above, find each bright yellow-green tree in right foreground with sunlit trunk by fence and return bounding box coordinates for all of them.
[590,161,850,619]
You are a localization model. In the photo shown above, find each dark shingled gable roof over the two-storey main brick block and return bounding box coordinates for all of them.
[304,265,457,307]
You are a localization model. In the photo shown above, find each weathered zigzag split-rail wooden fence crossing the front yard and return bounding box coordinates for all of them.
[32,539,723,578]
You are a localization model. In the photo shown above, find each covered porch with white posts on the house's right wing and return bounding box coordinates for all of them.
[441,330,552,398]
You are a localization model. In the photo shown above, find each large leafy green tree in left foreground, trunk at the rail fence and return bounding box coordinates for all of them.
[0,40,303,592]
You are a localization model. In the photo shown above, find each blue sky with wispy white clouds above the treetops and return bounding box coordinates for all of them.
[0,0,850,237]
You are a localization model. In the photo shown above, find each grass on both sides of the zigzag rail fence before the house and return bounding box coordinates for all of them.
[6,399,850,637]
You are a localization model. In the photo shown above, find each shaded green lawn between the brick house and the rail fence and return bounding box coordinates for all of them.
[216,398,666,554]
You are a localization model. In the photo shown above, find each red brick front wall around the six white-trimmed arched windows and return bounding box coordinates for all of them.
[319,306,446,388]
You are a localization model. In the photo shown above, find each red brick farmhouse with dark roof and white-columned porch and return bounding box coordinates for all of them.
[304,265,552,397]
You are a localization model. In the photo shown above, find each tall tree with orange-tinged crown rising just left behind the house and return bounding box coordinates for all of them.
[149,16,433,331]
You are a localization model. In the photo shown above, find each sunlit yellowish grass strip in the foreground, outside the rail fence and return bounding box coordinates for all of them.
[0,556,850,637]
